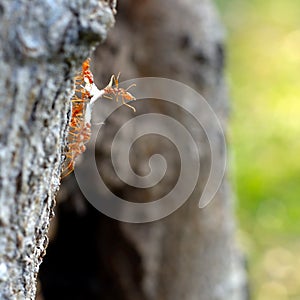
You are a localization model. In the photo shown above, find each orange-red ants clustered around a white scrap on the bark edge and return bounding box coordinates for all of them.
[61,58,136,178]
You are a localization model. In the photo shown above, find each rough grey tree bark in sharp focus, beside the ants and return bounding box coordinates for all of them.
[0,0,114,299]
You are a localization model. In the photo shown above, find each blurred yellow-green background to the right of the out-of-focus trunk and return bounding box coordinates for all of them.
[215,0,300,300]
